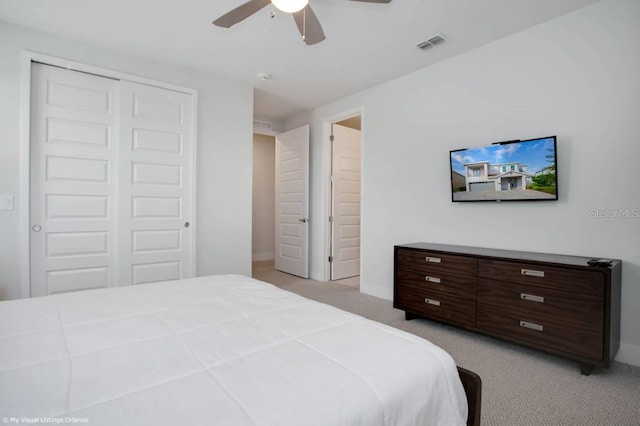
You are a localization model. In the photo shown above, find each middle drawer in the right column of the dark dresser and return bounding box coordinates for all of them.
[477,278,604,333]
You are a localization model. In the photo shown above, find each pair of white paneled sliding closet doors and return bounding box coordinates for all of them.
[30,63,193,296]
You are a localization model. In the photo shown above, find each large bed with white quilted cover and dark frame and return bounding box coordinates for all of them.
[0,275,480,426]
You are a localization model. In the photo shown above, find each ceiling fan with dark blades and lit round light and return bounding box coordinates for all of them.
[213,0,391,45]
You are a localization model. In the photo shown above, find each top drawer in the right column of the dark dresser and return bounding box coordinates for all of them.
[478,259,605,297]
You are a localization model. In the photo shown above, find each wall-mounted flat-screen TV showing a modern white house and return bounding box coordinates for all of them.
[450,136,558,202]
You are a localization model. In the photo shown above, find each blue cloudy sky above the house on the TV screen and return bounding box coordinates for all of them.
[451,138,555,175]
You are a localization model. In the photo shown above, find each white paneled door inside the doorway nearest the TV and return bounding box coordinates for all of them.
[331,124,362,280]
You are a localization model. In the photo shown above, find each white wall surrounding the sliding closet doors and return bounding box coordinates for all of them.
[0,22,253,299]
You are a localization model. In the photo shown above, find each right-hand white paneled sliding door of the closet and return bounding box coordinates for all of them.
[119,81,193,285]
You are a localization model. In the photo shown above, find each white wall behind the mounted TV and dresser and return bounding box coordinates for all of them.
[285,0,640,365]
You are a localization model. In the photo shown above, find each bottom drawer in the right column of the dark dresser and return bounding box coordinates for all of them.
[477,304,604,361]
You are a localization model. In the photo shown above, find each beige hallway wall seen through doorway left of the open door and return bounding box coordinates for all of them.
[252,134,276,261]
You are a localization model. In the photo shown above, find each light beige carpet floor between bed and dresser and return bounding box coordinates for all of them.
[253,264,640,426]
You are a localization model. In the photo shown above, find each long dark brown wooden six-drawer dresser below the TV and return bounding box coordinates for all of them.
[393,243,622,375]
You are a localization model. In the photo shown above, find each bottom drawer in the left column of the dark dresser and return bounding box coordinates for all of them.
[394,287,476,327]
